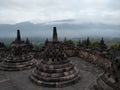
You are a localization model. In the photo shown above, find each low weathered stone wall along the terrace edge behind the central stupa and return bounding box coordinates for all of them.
[34,49,111,69]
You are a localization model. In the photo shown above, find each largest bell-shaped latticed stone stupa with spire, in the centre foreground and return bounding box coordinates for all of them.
[30,27,80,87]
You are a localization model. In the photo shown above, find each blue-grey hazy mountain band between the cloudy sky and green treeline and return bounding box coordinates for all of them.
[0,20,120,38]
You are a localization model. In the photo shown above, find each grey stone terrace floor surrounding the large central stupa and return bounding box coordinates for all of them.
[0,57,103,90]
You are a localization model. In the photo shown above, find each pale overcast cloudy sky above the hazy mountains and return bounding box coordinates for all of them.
[0,0,120,24]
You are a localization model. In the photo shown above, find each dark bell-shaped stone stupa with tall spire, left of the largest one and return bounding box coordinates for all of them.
[0,30,36,71]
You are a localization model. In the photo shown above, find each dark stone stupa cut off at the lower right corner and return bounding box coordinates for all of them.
[91,52,120,90]
